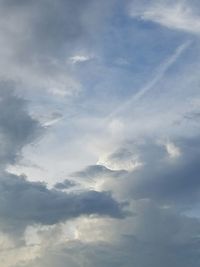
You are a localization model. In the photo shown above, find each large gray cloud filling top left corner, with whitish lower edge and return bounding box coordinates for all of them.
[0,0,115,97]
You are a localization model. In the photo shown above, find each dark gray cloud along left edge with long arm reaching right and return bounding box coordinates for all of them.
[0,87,124,236]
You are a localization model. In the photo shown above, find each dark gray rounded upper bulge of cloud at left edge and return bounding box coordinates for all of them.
[0,82,42,168]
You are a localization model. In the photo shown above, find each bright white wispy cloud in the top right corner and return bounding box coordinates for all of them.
[130,1,200,35]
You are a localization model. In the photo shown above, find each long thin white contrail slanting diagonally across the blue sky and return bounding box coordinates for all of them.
[106,41,192,121]
